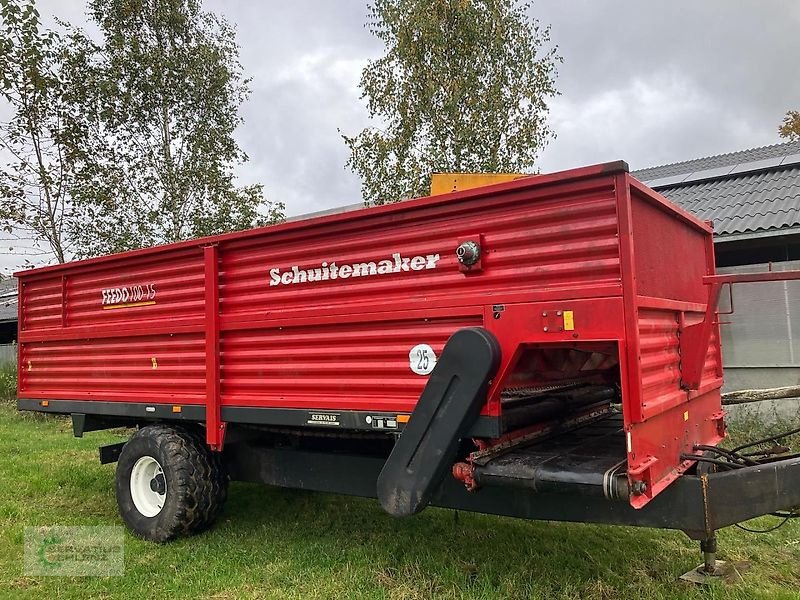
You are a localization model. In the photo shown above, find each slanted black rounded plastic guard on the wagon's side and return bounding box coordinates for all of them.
[378,327,500,517]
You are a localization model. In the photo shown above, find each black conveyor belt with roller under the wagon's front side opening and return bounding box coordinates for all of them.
[474,412,628,498]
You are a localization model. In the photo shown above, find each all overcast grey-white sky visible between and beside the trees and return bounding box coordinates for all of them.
[0,0,800,270]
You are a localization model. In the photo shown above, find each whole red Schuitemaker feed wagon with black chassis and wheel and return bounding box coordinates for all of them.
[17,162,800,576]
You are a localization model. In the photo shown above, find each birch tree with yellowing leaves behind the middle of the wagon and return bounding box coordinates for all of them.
[343,0,560,204]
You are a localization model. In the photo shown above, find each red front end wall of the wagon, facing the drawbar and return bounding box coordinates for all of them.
[624,176,722,506]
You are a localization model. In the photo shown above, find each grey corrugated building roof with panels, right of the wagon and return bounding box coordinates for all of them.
[632,142,800,241]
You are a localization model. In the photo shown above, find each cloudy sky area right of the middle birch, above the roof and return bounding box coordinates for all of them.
[534,0,800,170]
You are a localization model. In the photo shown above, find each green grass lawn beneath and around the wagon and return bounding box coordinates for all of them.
[0,403,800,600]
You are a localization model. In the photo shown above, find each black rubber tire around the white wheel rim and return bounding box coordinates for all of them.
[116,424,228,542]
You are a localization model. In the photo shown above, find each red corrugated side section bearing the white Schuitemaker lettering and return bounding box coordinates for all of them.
[220,172,620,411]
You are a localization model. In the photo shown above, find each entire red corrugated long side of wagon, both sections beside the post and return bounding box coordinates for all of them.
[14,168,621,412]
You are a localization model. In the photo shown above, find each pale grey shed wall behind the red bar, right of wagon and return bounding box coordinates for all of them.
[718,261,800,390]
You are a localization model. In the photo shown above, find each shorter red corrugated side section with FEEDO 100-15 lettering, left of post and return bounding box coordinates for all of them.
[19,248,206,404]
